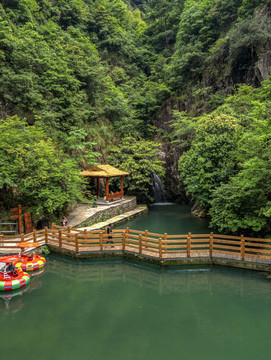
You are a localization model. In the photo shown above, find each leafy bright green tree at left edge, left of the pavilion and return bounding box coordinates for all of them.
[0,116,87,216]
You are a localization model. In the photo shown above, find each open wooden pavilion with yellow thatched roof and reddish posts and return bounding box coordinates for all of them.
[80,165,129,201]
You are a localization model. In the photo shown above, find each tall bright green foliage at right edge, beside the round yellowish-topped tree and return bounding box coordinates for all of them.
[210,84,271,235]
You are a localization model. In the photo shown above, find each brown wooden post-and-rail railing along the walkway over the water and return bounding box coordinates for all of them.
[0,224,271,263]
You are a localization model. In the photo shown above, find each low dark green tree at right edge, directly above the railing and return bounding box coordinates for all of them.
[209,162,271,236]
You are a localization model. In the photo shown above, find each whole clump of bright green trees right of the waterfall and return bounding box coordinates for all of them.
[175,80,271,234]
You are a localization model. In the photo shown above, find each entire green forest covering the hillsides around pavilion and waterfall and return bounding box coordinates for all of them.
[0,0,271,236]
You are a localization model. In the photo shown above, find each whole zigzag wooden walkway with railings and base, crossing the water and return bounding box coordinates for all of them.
[0,225,271,271]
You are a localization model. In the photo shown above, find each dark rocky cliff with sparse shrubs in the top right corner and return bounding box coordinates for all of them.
[206,3,271,95]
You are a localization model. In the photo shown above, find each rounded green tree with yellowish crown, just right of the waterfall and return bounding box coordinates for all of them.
[179,114,238,208]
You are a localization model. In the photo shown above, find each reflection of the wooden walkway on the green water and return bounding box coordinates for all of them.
[48,257,271,298]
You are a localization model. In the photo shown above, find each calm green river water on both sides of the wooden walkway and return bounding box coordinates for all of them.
[0,206,271,360]
